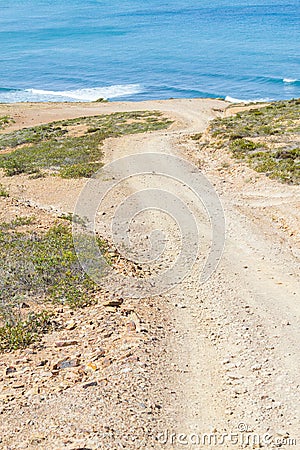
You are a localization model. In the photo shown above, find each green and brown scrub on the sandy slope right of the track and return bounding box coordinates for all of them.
[199,99,300,184]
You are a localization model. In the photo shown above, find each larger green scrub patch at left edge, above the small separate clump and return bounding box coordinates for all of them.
[0,218,105,308]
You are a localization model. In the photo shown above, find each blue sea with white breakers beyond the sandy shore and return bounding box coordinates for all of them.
[0,0,300,102]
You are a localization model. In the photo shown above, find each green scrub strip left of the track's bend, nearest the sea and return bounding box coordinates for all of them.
[0,111,171,178]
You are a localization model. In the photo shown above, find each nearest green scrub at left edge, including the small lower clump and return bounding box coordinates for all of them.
[0,217,109,351]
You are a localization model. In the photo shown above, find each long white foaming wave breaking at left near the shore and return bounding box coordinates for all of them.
[0,84,142,103]
